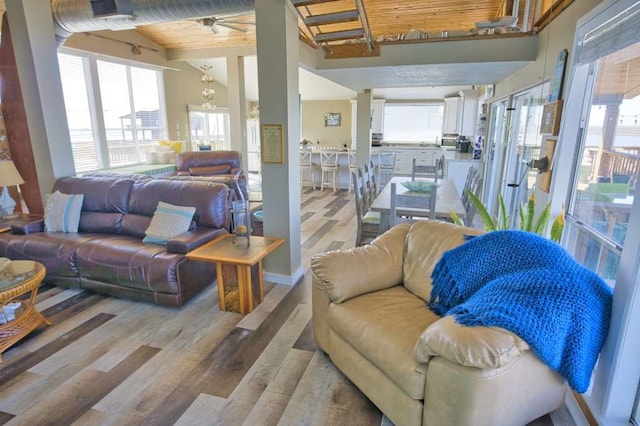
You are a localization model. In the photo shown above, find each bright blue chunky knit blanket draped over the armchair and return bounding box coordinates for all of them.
[429,231,612,393]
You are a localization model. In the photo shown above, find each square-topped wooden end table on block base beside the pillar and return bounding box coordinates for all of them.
[186,234,284,314]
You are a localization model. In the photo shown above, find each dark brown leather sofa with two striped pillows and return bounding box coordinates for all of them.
[0,175,230,306]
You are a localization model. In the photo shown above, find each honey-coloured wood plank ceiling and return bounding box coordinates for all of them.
[138,0,524,50]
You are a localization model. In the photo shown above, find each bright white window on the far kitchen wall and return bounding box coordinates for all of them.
[383,103,444,143]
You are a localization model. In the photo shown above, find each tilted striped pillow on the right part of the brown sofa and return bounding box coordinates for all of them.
[142,201,196,244]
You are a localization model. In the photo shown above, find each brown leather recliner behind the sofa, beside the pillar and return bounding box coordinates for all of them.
[170,151,249,200]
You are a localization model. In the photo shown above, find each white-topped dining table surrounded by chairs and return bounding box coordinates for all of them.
[369,176,465,232]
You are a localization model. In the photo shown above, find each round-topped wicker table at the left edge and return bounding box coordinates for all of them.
[0,260,51,362]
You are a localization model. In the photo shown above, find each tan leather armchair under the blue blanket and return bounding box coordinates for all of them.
[311,221,567,426]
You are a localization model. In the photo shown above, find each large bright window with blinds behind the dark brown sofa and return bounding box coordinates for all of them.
[58,53,167,172]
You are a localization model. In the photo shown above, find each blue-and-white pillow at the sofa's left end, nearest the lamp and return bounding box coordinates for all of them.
[44,191,84,233]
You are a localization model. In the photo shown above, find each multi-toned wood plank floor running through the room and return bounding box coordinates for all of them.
[0,188,572,426]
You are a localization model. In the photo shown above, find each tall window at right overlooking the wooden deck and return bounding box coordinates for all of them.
[554,0,640,424]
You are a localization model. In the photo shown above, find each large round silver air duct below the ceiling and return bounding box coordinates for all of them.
[51,0,255,46]
